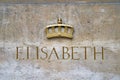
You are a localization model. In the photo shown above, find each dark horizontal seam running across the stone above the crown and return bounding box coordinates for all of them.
[0,1,120,5]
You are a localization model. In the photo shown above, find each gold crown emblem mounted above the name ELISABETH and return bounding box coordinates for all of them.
[45,18,74,38]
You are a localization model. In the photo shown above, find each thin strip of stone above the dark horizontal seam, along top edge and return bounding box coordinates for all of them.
[0,0,120,3]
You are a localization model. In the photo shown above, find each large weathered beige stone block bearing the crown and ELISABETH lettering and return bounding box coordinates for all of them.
[0,3,120,80]
